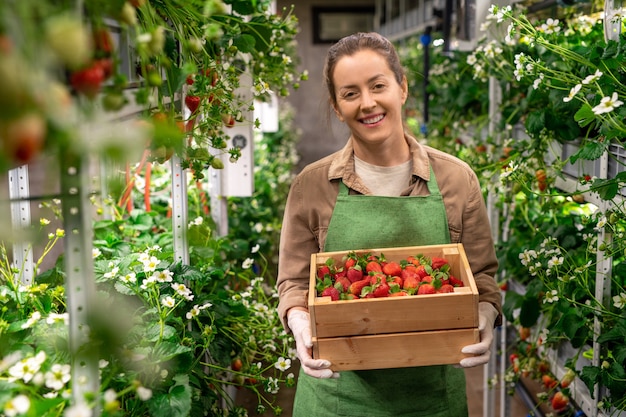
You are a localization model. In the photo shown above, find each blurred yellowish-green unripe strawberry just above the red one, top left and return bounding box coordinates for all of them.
[45,15,93,70]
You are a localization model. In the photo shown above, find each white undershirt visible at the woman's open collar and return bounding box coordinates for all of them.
[354,156,413,197]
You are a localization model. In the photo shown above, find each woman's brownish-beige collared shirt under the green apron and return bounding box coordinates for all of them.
[277,135,501,329]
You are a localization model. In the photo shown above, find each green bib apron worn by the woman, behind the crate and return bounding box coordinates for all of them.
[293,168,468,417]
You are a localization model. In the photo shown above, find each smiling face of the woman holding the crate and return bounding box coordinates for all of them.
[333,49,407,146]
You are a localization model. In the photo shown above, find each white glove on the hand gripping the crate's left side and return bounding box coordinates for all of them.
[287,309,339,378]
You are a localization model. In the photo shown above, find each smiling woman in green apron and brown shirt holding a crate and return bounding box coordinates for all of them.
[277,33,500,417]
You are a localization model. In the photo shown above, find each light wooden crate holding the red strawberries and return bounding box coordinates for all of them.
[309,244,479,371]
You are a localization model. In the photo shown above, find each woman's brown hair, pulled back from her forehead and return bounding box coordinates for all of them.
[324,32,405,105]
